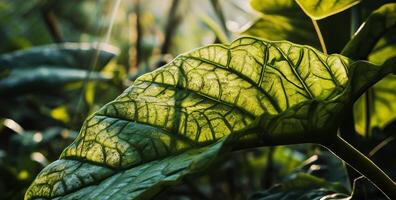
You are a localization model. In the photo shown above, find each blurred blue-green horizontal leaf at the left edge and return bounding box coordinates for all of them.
[0,43,117,96]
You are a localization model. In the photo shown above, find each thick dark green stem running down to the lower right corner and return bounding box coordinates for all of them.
[324,136,396,199]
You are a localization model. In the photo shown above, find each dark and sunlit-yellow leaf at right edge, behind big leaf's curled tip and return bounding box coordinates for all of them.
[343,3,396,133]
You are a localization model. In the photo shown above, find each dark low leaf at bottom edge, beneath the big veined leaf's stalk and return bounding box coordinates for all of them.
[249,173,349,200]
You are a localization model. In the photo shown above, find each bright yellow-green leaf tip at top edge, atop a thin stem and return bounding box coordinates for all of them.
[295,0,360,20]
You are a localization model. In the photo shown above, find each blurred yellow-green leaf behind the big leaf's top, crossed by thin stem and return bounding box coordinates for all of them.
[242,0,350,53]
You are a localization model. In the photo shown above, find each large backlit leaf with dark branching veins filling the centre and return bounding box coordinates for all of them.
[26,37,390,199]
